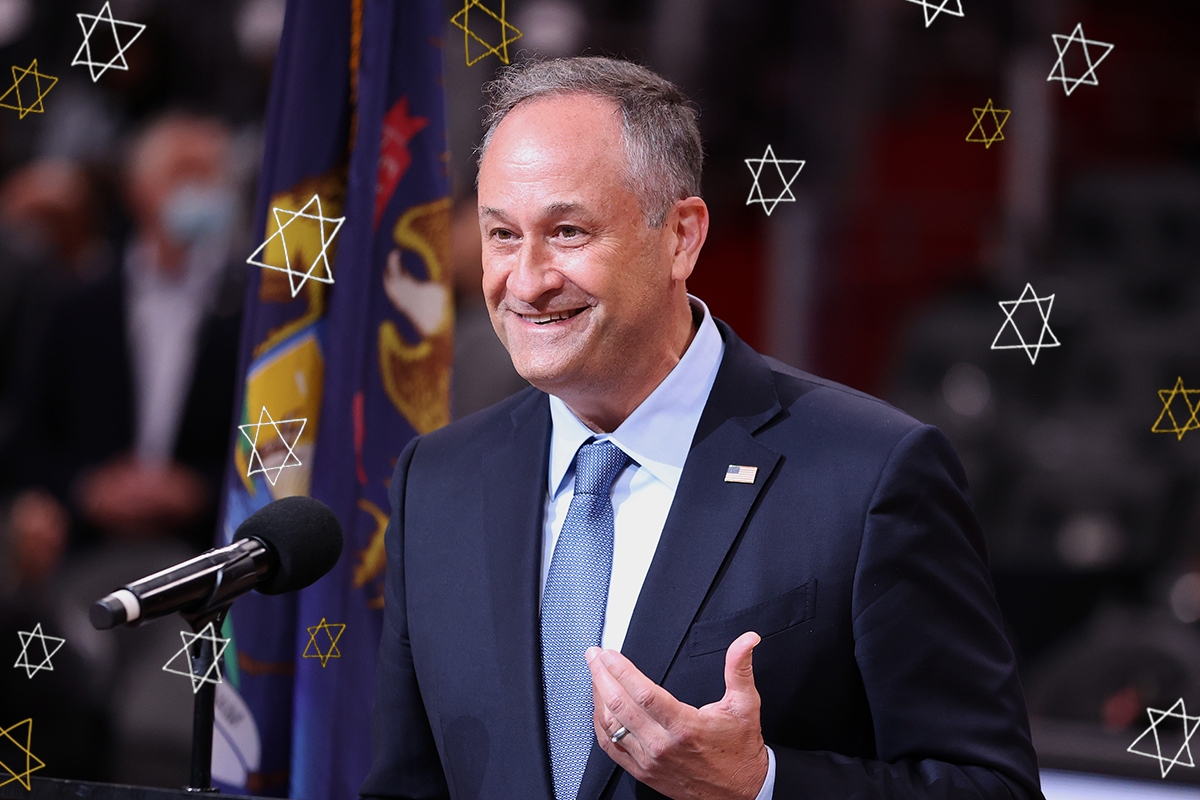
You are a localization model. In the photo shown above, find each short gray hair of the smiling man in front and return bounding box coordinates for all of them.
[479,56,704,228]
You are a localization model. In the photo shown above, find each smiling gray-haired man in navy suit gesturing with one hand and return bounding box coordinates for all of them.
[362,59,1040,800]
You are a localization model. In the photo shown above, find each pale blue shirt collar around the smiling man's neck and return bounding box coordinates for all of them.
[548,295,725,497]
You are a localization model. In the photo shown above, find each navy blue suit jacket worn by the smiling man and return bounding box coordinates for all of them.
[362,324,1040,800]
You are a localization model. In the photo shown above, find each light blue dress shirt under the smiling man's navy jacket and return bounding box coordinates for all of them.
[541,295,775,800]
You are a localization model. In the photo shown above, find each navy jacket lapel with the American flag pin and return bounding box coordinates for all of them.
[578,321,780,800]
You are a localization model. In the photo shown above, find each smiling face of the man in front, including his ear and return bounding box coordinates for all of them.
[479,95,708,431]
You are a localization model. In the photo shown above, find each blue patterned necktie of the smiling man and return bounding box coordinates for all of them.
[541,441,629,800]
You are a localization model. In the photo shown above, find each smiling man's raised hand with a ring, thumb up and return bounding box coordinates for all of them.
[587,633,769,800]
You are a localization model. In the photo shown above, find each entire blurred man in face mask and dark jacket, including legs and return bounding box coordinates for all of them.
[5,114,244,783]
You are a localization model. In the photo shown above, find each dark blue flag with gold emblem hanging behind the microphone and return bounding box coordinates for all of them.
[212,0,452,800]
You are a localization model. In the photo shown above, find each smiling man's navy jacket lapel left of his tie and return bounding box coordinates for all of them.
[480,392,553,798]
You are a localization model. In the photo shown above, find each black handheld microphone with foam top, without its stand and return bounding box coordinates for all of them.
[89,497,342,631]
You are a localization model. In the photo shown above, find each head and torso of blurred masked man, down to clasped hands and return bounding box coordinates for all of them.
[2,115,241,582]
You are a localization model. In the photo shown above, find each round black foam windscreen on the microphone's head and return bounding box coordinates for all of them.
[234,497,342,595]
